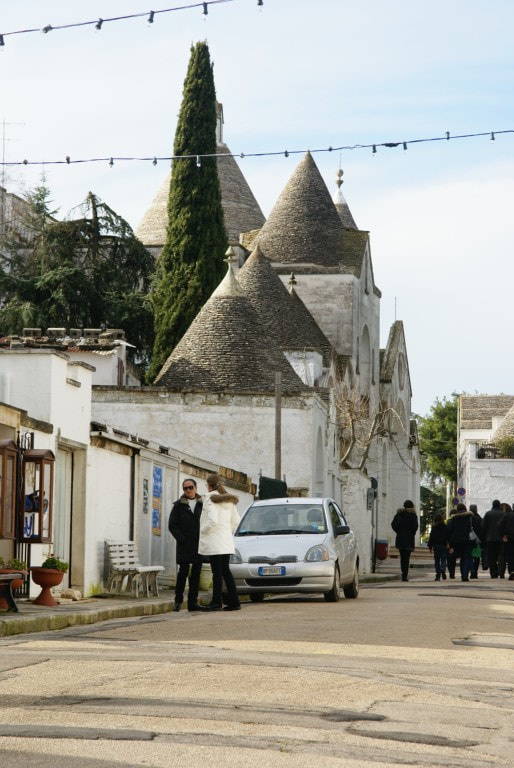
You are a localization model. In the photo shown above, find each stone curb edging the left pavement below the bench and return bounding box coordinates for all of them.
[0,600,173,637]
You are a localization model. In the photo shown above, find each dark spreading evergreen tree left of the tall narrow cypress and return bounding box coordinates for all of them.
[0,187,154,363]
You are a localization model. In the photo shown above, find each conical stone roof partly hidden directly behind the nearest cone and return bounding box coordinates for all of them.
[237,246,332,366]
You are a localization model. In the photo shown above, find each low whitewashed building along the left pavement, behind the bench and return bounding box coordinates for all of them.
[0,348,255,595]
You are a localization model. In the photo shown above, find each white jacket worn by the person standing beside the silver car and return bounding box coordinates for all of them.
[198,491,239,555]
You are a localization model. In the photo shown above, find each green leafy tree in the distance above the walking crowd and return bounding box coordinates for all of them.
[419,397,457,482]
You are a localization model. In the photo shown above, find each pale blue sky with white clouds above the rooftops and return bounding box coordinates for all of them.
[0,0,514,415]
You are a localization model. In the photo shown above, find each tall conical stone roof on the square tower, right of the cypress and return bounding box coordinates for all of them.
[256,152,344,267]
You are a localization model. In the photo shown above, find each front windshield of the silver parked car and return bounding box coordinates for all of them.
[235,504,327,536]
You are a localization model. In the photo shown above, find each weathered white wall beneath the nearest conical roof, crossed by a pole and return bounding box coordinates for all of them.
[93,387,326,489]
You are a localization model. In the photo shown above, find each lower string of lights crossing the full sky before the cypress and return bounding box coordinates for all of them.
[0,128,508,168]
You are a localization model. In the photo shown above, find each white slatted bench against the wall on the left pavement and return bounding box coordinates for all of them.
[105,539,164,597]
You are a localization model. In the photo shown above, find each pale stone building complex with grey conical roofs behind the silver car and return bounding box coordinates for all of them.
[93,153,419,571]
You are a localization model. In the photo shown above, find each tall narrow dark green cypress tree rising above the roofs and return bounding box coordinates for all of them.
[148,42,227,381]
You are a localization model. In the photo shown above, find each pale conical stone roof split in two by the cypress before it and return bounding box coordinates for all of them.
[136,144,265,247]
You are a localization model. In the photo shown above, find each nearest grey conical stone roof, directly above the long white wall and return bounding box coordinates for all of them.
[155,268,307,393]
